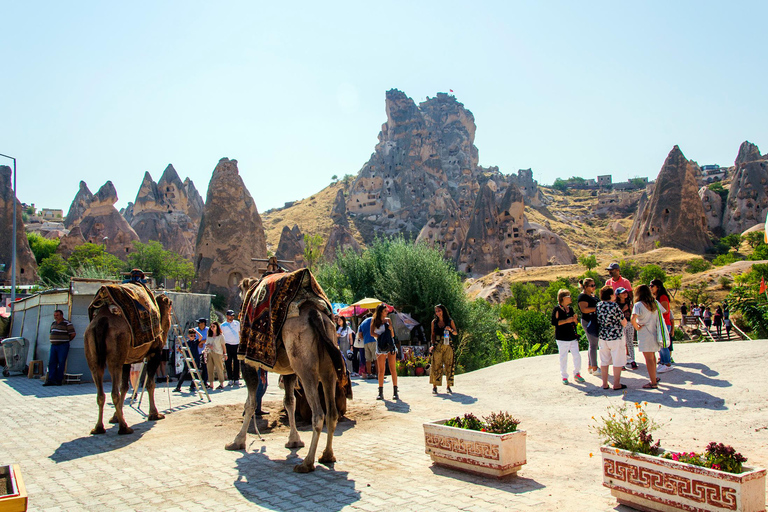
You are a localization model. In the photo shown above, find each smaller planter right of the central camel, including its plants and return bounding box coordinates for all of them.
[424,412,527,477]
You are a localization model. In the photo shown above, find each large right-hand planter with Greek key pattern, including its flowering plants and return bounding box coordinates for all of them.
[595,404,766,512]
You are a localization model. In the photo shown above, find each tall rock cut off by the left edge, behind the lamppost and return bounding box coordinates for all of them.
[0,165,38,286]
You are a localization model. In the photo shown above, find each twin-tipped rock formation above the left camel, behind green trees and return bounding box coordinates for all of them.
[67,181,139,260]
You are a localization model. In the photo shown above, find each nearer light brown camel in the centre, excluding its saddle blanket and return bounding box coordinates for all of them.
[225,278,343,473]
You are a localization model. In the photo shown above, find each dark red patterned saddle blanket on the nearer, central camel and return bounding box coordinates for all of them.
[237,268,333,369]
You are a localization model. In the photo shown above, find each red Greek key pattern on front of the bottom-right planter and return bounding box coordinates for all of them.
[603,459,736,510]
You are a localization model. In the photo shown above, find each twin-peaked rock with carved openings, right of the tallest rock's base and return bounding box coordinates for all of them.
[457,183,576,275]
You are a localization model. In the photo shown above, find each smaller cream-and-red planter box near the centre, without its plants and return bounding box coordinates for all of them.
[424,420,527,478]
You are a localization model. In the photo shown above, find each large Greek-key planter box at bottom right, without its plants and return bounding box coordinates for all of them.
[600,446,766,512]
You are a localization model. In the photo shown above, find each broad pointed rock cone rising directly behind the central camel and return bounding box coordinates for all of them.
[194,158,267,308]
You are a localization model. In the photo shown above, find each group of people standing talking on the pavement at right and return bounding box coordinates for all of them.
[552,263,675,390]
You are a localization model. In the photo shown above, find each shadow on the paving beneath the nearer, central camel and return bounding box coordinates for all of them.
[234,448,360,512]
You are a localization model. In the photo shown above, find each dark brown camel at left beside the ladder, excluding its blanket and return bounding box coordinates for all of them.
[83,285,172,434]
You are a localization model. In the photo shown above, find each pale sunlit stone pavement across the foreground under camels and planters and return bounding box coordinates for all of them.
[0,341,768,512]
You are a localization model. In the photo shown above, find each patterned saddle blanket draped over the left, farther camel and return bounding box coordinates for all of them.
[88,283,165,348]
